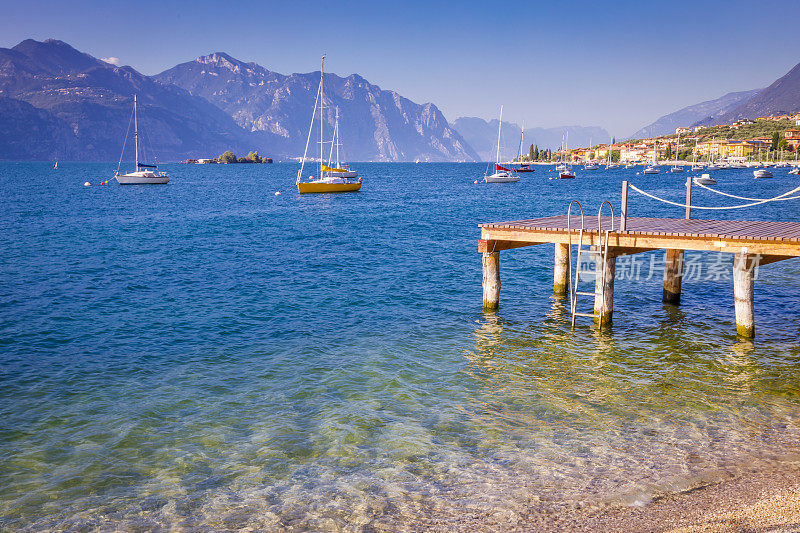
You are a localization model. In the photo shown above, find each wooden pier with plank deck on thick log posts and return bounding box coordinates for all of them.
[478,215,800,338]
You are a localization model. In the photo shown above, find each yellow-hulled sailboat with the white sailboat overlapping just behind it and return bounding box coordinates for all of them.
[297,56,361,194]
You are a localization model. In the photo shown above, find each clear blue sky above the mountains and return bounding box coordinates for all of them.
[0,0,800,137]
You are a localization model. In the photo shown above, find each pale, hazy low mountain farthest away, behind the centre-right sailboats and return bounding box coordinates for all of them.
[452,117,611,161]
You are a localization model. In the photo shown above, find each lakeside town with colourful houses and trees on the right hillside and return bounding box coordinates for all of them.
[513,113,800,165]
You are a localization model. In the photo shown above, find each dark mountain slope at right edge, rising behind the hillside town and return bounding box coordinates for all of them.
[698,60,800,126]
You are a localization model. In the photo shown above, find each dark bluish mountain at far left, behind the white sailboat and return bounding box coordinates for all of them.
[0,39,263,161]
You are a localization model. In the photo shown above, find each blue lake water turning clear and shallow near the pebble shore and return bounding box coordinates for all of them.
[0,163,800,530]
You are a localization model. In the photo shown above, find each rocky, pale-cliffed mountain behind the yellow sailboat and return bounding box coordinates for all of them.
[155,53,477,161]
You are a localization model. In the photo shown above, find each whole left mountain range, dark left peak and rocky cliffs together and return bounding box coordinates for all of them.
[0,39,478,161]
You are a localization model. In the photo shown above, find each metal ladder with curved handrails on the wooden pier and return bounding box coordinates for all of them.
[567,200,614,328]
